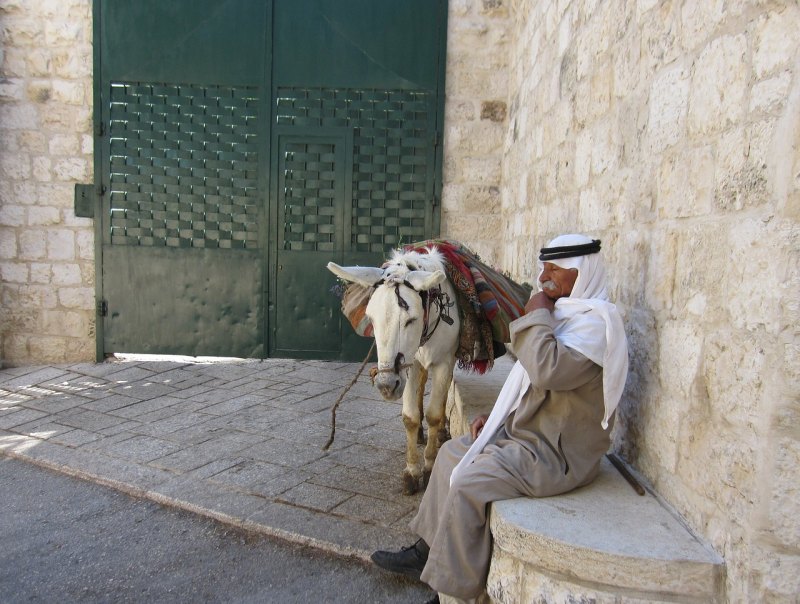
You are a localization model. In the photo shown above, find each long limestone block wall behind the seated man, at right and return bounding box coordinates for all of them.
[501,0,800,602]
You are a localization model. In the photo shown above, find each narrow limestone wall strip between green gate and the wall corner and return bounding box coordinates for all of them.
[441,0,511,264]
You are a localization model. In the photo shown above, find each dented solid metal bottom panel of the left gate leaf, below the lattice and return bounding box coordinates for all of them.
[103,245,264,358]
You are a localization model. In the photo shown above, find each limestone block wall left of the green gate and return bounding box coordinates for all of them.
[0,0,95,365]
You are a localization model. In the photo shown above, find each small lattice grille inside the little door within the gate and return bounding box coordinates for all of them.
[282,142,337,252]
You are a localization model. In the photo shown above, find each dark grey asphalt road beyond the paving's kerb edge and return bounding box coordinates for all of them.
[0,458,433,604]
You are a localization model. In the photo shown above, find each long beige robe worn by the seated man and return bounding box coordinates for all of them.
[410,309,611,598]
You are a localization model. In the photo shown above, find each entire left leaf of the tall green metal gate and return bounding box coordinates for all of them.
[95,0,270,357]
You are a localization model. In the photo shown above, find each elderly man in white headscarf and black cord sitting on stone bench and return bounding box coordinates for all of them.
[372,235,628,599]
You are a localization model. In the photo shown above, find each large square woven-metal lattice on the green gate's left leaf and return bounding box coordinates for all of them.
[109,84,258,248]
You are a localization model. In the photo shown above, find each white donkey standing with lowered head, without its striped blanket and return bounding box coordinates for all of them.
[328,248,461,495]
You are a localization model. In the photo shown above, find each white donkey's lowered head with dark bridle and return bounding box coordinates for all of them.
[328,252,446,400]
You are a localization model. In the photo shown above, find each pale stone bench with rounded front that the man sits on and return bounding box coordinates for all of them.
[442,357,725,604]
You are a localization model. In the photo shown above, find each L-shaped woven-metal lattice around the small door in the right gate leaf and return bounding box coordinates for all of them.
[276,88,434,253]
